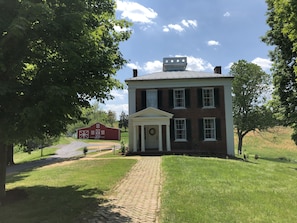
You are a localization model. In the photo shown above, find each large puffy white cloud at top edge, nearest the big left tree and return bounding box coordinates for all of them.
[116,0,158,23]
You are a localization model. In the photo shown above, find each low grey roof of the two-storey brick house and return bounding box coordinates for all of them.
[125,70,233,82]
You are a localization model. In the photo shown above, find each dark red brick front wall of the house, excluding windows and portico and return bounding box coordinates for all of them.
[136,86,227,154]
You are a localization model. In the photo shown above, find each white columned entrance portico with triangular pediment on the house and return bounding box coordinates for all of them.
[129,107,173,152]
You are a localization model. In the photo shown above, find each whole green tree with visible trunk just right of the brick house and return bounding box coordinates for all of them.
[230,60,274,154]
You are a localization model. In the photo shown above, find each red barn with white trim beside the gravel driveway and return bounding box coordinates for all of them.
[77,123,121,140]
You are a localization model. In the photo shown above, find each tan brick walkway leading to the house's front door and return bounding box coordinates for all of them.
[88,157,161,223]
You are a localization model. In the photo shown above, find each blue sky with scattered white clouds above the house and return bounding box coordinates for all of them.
[99,0,272,117]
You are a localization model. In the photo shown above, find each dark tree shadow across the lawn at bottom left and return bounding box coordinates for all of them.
[0,185,131,223]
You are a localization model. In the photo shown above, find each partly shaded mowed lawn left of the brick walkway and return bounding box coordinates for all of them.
[0,159,136,223]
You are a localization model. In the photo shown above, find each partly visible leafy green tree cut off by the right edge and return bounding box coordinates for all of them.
[262,0,297,144]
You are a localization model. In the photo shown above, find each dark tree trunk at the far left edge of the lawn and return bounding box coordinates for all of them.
[0,142,7,203]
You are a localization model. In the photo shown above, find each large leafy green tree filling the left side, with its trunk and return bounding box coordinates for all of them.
[0,0,130,200]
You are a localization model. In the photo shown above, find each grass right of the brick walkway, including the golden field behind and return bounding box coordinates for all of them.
[161,128,297,223]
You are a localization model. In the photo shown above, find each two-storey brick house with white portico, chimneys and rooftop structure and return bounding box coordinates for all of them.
[125,57,234,156]
